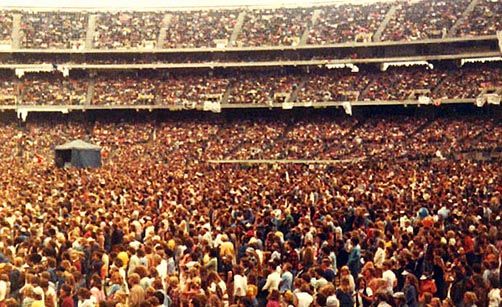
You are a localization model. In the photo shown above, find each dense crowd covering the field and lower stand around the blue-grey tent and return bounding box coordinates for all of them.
[0,111,502,307]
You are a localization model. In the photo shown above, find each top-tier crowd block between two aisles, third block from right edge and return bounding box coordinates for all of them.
[308,3,390,45]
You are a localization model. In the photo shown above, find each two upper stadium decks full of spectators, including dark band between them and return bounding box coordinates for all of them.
[0,0,502,109]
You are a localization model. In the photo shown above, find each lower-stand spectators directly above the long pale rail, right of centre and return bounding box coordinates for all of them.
[212,116,502,160]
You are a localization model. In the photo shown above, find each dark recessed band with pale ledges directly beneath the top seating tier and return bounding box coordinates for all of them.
[0,35,501,69]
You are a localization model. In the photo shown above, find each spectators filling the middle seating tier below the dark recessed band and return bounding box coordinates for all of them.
[0,63,502,106]
